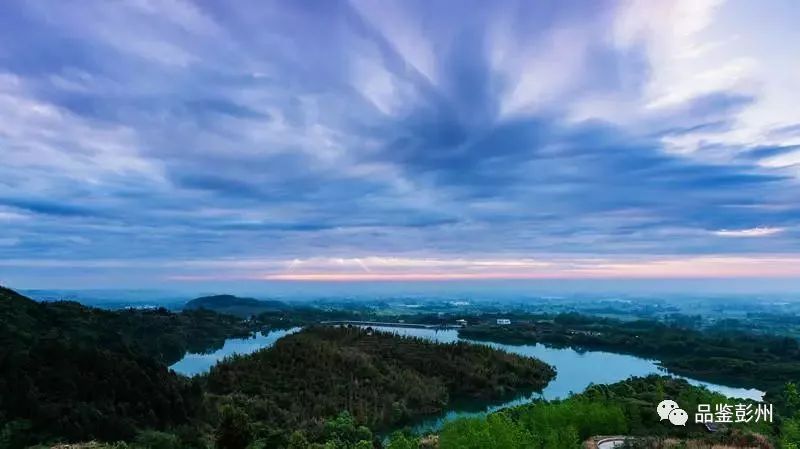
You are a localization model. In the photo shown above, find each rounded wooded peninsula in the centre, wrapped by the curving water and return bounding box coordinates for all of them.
[207,327,554,429]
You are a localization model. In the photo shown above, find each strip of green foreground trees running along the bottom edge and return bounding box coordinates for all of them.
[10,376,800,449]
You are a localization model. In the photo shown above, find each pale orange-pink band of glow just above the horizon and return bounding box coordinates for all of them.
[162,256,800,282]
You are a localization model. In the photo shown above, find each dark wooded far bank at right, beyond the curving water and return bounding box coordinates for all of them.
[459,314,800,391]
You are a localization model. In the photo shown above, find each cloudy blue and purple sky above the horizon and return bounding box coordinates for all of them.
[0,0,800,288]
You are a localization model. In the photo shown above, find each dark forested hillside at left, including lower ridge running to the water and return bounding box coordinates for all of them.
[0,287,266,442]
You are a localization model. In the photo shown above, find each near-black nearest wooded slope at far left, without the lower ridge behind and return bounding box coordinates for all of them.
[0,288,201,445]
